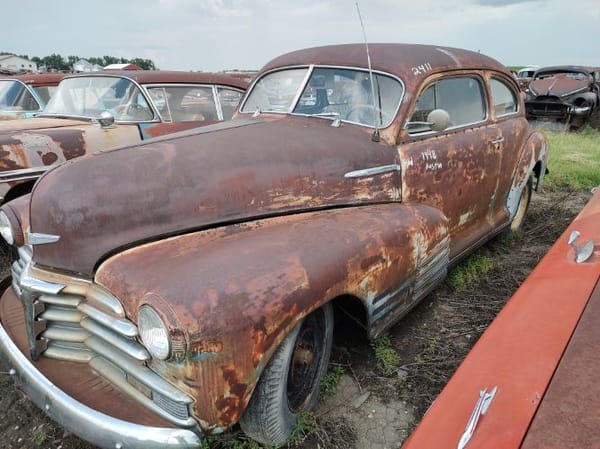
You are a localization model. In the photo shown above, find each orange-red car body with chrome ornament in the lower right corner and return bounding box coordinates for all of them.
[402,188,600,449]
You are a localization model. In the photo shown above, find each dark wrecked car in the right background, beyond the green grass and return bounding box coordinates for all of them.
[525,65,600,130]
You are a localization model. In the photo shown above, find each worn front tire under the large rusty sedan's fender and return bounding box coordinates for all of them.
[240,303,333,446]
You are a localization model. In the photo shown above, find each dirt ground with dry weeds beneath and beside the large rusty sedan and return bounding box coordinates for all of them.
[0,186,591,449]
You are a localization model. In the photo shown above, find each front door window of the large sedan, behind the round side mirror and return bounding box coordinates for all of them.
[409,76,486,134]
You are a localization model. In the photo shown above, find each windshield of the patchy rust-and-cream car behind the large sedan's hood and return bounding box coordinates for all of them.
[43,76,154,122]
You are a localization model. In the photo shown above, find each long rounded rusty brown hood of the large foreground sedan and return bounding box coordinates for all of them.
[30,117,400,276]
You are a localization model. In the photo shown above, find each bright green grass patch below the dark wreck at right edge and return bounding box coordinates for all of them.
[543,127,600,190]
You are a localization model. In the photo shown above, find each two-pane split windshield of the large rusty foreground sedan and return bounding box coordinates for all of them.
[242,67,403,127]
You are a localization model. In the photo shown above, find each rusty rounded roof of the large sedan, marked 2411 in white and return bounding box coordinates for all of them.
[262,43,511,79]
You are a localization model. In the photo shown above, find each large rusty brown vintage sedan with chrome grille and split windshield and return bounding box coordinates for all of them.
[0,44,548,448]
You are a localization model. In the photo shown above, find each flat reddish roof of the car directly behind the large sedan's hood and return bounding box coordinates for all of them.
[61,70,248,90]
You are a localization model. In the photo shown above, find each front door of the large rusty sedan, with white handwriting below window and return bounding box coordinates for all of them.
[399,72,503,259]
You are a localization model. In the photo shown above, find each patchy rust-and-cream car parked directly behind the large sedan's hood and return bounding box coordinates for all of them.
[0,70,248,202]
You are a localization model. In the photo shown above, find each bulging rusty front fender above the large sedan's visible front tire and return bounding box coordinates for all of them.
[96,203,448,430]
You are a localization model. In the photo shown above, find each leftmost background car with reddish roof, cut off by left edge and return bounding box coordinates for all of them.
[0,73,66,120]
